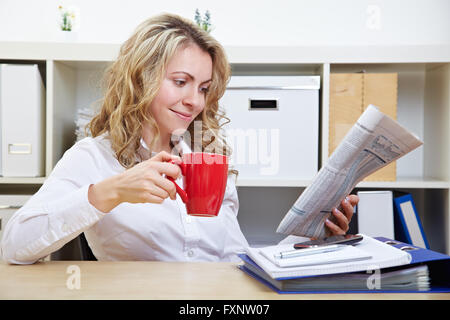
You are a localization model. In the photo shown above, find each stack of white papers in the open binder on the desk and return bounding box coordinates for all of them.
[240,235,430,291]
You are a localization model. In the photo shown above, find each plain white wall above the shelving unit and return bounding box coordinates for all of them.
[0,0,450,46]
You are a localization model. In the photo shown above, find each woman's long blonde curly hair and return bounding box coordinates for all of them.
[88,14,236,173]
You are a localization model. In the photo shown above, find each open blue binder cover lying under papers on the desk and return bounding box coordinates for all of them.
[239,237,450,294]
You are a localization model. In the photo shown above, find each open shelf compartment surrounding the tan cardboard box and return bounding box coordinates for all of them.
[322,63,450,185]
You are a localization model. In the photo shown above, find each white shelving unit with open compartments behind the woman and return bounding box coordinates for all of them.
[0,42,450,253]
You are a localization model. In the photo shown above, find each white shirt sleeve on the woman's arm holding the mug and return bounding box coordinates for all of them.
[0,139,107,264]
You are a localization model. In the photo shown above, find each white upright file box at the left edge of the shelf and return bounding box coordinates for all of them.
[0,64,45,177]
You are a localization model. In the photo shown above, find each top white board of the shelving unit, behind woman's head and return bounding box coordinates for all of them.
[0,41,450,64]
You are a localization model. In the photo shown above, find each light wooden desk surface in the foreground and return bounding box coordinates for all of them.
[0,261,450,300]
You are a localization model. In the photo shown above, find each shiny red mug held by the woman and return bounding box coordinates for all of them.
[167,152,228,217]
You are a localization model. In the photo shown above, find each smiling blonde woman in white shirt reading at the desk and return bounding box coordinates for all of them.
[2,14,357,264]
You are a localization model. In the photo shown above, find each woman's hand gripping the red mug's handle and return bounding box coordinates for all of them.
[88,151,181,212]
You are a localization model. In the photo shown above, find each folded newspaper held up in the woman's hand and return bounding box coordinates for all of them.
[277,105,423,239]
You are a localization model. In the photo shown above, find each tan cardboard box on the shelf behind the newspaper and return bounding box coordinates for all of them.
[328,73,398,181]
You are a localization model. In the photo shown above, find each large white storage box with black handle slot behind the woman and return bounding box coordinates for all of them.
[220,76,320,181]
